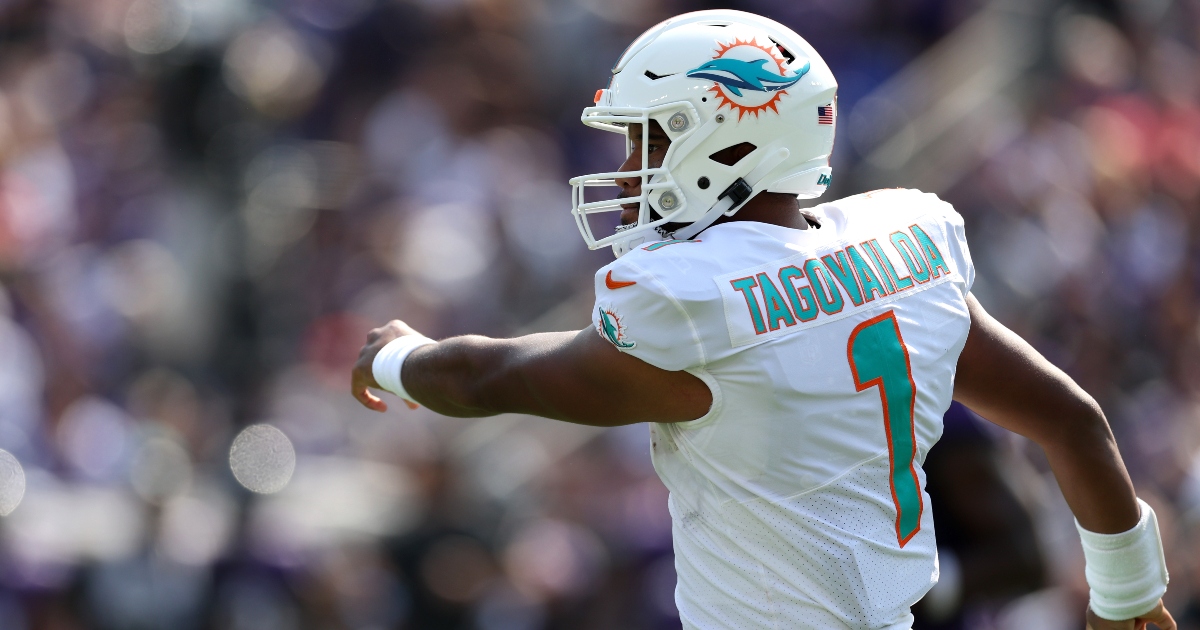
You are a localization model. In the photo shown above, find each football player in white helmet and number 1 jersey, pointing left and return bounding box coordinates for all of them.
[352,11,1175,630]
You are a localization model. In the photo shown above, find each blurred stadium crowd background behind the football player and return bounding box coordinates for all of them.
[0,0,1200,630]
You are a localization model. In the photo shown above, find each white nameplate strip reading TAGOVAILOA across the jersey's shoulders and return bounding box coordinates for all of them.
[713,224,953,348]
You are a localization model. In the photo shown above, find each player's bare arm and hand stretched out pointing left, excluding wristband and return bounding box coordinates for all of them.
[352,322,713,426]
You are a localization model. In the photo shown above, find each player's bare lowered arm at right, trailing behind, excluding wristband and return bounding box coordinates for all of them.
[954,295,1175,630]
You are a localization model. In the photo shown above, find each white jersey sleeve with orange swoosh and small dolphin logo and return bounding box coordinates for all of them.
[592,254,706,372]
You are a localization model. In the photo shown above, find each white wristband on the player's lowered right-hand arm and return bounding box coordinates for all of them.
[1075,499,1168,622]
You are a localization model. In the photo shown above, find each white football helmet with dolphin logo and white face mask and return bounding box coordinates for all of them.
[570,10,838,257]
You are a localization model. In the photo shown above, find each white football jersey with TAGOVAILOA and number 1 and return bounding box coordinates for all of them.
[593,190,974,630]
